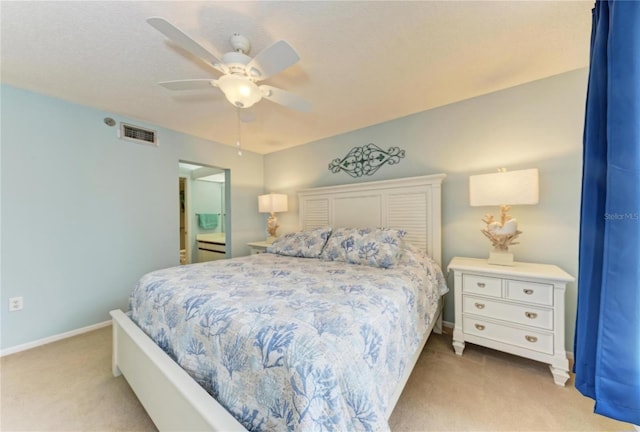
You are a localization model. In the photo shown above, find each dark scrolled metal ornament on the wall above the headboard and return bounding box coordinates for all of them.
[329,143,404,177]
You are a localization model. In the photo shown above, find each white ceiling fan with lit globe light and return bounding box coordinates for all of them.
[147,17,311,112]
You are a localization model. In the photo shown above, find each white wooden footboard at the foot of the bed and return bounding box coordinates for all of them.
[111,310,246,432]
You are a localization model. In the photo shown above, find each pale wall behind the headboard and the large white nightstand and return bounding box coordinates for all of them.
[265,69,587,351]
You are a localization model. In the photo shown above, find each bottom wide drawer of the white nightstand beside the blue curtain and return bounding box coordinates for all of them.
[462,316,553,354]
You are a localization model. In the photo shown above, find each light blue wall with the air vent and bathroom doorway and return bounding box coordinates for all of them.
[0,85,263,349]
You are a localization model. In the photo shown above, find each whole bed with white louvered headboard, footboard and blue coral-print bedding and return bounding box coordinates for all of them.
[112,175,446,431]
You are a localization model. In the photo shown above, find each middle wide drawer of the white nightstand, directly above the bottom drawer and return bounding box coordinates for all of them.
[462,296,553,330]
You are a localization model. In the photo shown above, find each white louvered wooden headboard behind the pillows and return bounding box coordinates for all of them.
[298,174,446,264]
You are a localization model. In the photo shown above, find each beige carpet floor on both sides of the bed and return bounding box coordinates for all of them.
[0,327,634,432]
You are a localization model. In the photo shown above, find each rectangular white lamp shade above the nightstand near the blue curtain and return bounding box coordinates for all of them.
[469,168,538,207]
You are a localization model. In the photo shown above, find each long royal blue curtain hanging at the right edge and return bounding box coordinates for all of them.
[574,1,640,425]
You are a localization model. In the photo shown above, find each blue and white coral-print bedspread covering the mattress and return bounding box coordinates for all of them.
[129,245,447,431]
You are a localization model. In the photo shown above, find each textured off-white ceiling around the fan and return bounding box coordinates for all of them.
[0,1,593,153]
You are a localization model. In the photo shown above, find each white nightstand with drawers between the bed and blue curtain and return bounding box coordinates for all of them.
[448,257,575,386]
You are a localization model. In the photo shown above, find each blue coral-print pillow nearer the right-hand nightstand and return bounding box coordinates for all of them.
[320,228,405,268]
